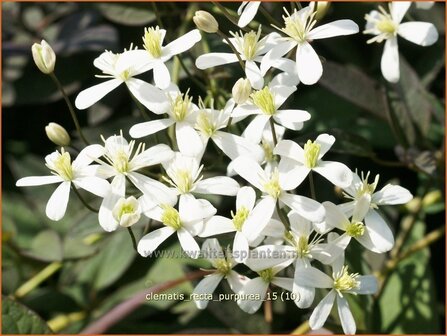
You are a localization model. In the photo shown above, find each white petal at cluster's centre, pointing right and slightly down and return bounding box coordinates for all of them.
[212,131,264,161]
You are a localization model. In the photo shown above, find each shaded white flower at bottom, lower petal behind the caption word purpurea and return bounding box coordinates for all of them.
[237,245,293,314]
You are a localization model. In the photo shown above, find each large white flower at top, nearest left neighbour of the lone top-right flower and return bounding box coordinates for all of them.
[261,2,359,85]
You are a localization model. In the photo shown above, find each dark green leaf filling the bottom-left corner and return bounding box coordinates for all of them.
[2,296,53,334]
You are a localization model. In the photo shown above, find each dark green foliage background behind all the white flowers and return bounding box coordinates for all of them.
[2,2,445,333]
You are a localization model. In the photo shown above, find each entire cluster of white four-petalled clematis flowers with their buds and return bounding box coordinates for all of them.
[17,2,437,334]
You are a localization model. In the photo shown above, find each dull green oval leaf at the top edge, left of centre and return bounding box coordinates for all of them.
[97,3,155,26]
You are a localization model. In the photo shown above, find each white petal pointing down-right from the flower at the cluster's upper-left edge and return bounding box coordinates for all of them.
[126,78,170,114]
